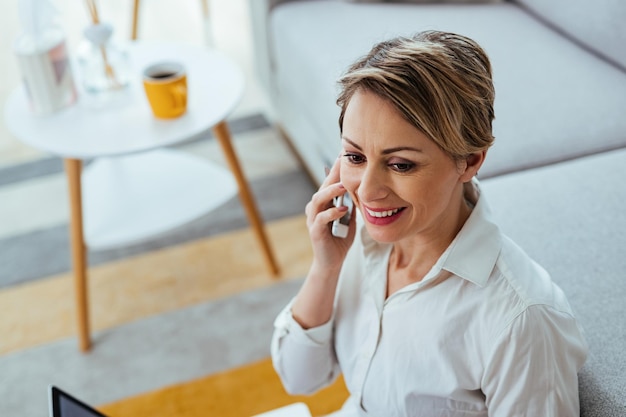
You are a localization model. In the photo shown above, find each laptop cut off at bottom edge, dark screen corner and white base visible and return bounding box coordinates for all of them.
[50,385,311,417]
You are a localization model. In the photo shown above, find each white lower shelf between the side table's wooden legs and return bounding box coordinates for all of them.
[82,149,237,250]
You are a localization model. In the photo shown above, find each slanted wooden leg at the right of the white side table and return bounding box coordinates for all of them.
[213,121,279,277]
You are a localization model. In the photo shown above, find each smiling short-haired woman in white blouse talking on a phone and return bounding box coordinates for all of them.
[272,32,587,417]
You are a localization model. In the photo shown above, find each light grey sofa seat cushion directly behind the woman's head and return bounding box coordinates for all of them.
[270,0,626,184]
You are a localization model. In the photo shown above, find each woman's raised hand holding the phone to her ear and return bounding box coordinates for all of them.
[305,159,356,274]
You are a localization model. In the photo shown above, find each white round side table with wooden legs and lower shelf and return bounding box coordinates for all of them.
[5,41,279,351]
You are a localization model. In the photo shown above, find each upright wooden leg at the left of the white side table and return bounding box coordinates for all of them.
[65,159,91,352]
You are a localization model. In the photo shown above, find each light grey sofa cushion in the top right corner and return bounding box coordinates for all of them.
[516,0,626,70]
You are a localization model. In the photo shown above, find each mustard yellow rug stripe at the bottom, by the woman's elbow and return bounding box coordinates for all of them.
[99,359,348,417]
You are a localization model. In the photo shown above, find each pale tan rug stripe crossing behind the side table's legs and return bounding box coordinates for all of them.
[0,216,312,355]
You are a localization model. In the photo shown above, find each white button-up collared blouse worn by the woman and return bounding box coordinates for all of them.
[272,181,587,417]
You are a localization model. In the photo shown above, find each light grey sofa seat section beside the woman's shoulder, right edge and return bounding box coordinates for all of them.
[482,150,626,417]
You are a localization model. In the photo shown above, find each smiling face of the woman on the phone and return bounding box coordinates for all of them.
[340,90,472,243]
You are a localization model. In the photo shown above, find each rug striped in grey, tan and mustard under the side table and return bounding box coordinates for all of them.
[0,115,345,417]
